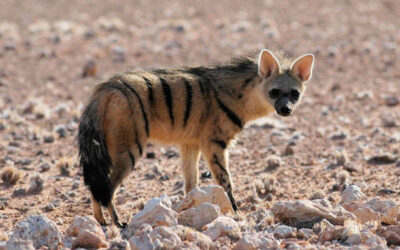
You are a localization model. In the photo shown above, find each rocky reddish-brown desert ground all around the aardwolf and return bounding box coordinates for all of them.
[0,0,400,249]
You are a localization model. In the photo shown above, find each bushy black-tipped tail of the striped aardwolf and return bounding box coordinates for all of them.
[78,100,112,207]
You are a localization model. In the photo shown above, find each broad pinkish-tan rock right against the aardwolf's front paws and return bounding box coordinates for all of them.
[175,185,233,214]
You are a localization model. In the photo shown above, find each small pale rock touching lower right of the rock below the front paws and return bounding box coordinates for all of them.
[203,216,240,240]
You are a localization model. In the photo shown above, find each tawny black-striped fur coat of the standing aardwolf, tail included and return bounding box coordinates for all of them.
[78,48,316,226]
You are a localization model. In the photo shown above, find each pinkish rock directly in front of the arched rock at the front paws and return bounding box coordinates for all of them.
[178,202,221,230]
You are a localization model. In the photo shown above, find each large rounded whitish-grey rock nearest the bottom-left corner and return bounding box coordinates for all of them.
[11,215,62,249]
